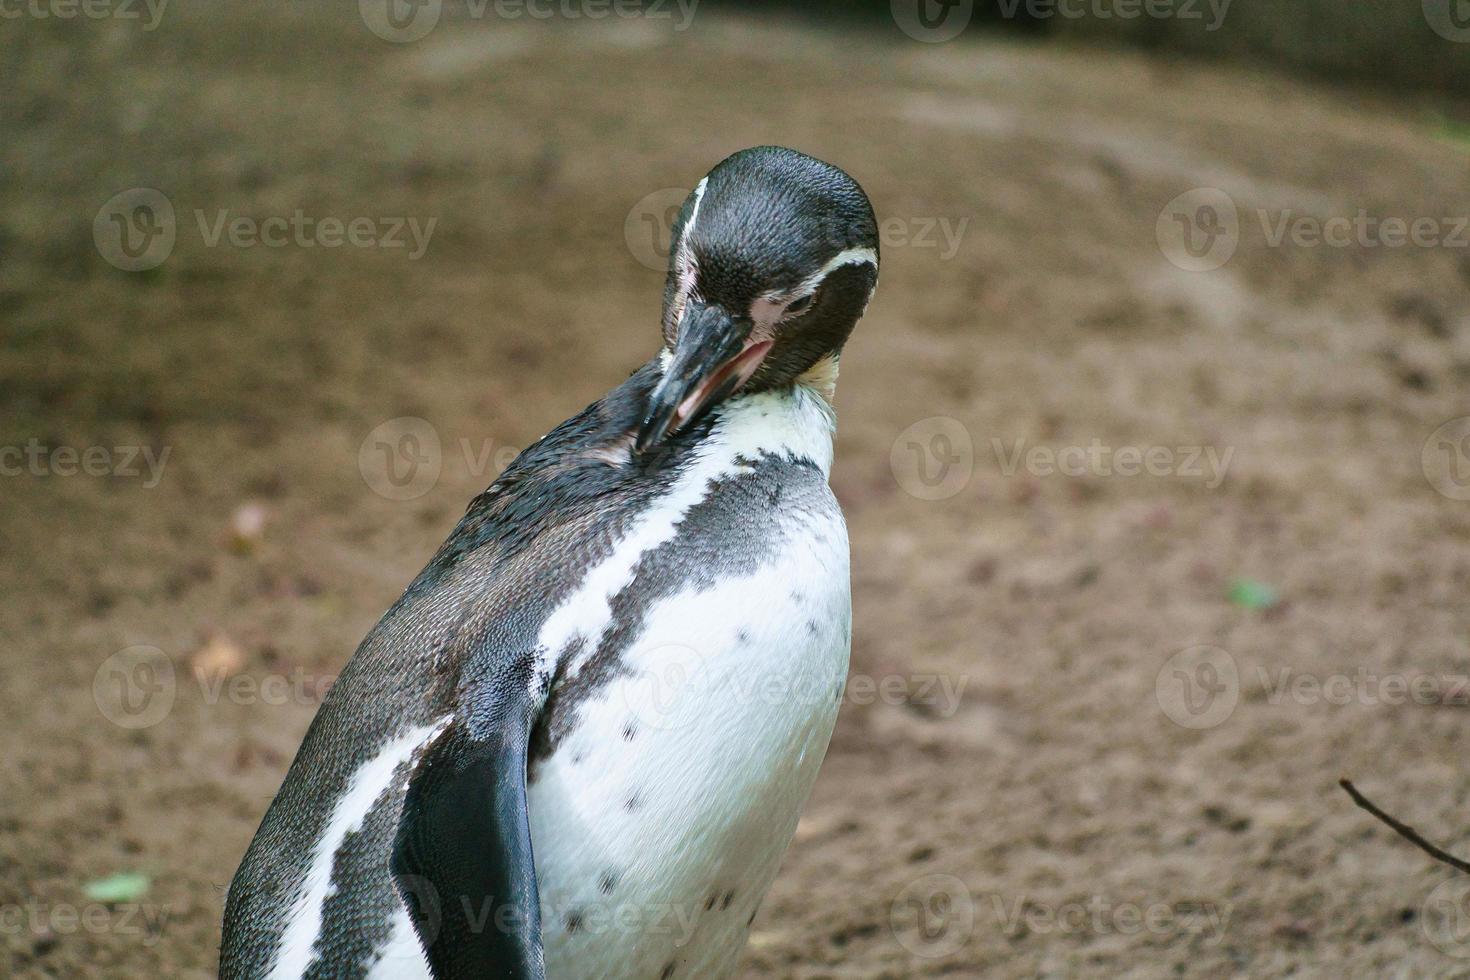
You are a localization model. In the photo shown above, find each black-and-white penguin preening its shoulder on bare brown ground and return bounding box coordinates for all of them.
[221,147,879,980]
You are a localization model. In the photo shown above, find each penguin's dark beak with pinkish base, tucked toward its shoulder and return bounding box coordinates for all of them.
[634,300,770,453]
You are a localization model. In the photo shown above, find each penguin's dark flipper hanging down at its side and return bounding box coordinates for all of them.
[391,723,545,980]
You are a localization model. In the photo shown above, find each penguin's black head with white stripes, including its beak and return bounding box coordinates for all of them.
[637,147,878,451]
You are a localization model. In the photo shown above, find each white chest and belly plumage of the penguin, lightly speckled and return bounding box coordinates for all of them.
[529,392,851,979]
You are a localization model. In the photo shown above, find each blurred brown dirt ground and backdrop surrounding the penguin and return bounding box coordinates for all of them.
[0,0,1470,980]
